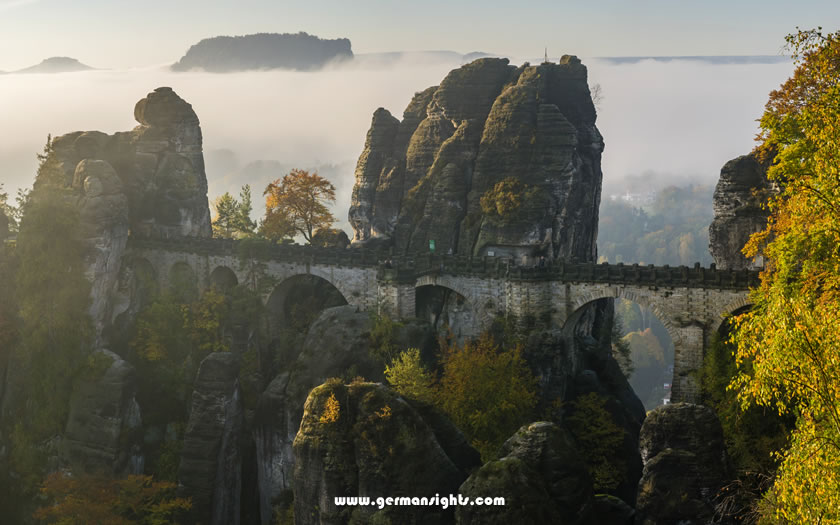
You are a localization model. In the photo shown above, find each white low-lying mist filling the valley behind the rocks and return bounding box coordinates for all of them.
[0,57,792,229]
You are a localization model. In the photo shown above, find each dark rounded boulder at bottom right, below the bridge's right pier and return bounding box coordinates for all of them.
[636,403,730,525]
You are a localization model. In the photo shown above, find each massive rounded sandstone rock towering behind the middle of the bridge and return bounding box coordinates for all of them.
[349,55,604,261]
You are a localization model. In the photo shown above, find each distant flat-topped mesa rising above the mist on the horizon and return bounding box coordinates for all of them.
[172,33,353,73]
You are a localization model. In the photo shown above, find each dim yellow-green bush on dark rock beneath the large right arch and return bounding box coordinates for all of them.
[566,392,626,493]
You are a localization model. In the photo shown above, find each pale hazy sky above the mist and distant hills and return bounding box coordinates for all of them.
[0,0,840,71]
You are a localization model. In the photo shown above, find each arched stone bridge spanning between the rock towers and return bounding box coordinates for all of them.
[124,236,758,401]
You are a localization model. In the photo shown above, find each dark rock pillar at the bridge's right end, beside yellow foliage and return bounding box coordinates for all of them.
[709,150,774,270]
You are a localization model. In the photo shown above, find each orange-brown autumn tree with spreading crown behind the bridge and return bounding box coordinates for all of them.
[260,169,335,243]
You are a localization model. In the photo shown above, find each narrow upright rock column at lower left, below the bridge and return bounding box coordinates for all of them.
[178,352,243,525]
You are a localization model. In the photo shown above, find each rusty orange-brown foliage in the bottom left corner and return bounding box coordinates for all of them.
[34,472,192,525]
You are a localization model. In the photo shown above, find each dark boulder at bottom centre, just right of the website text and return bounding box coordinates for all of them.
[456,422,592,525]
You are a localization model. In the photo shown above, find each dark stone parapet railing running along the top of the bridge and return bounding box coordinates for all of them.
[129,235,759,290]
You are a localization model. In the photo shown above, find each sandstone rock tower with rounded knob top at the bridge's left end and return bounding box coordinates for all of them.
[53,87,212,237]
